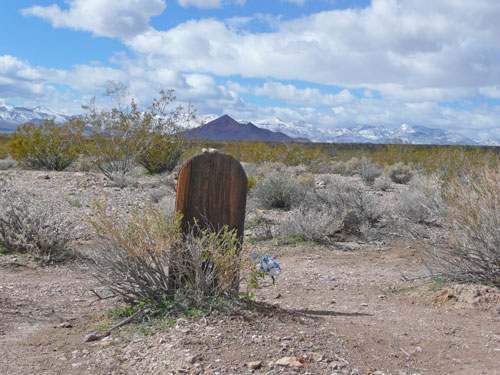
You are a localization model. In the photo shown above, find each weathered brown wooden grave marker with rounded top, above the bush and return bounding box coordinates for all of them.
[175,151,248,291]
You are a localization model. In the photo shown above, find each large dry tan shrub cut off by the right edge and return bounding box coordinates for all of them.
[430,167,500,287]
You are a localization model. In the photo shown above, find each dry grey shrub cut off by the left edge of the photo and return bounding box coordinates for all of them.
[0,191,75,263]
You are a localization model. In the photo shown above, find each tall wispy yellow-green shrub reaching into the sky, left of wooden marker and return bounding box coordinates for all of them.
[82,84,194,180]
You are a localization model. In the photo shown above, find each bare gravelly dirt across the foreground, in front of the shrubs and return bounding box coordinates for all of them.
[0,242,500,375]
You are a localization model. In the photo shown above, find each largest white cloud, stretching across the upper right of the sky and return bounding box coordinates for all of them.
[127,0,500,100]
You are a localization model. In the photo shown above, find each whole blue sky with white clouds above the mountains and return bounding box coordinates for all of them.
[0,0,500,140]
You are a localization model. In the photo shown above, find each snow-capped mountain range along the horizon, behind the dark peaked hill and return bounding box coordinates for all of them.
[0,101,500,146]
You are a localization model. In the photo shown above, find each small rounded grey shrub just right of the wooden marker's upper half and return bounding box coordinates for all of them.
[253,171,307,210]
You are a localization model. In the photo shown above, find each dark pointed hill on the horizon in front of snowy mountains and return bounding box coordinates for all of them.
[185,115,310,142]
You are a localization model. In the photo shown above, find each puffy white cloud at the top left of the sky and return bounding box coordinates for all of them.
[22,0,165,38]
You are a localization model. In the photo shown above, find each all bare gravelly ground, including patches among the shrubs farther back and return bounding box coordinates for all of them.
[0,170,500,375]
